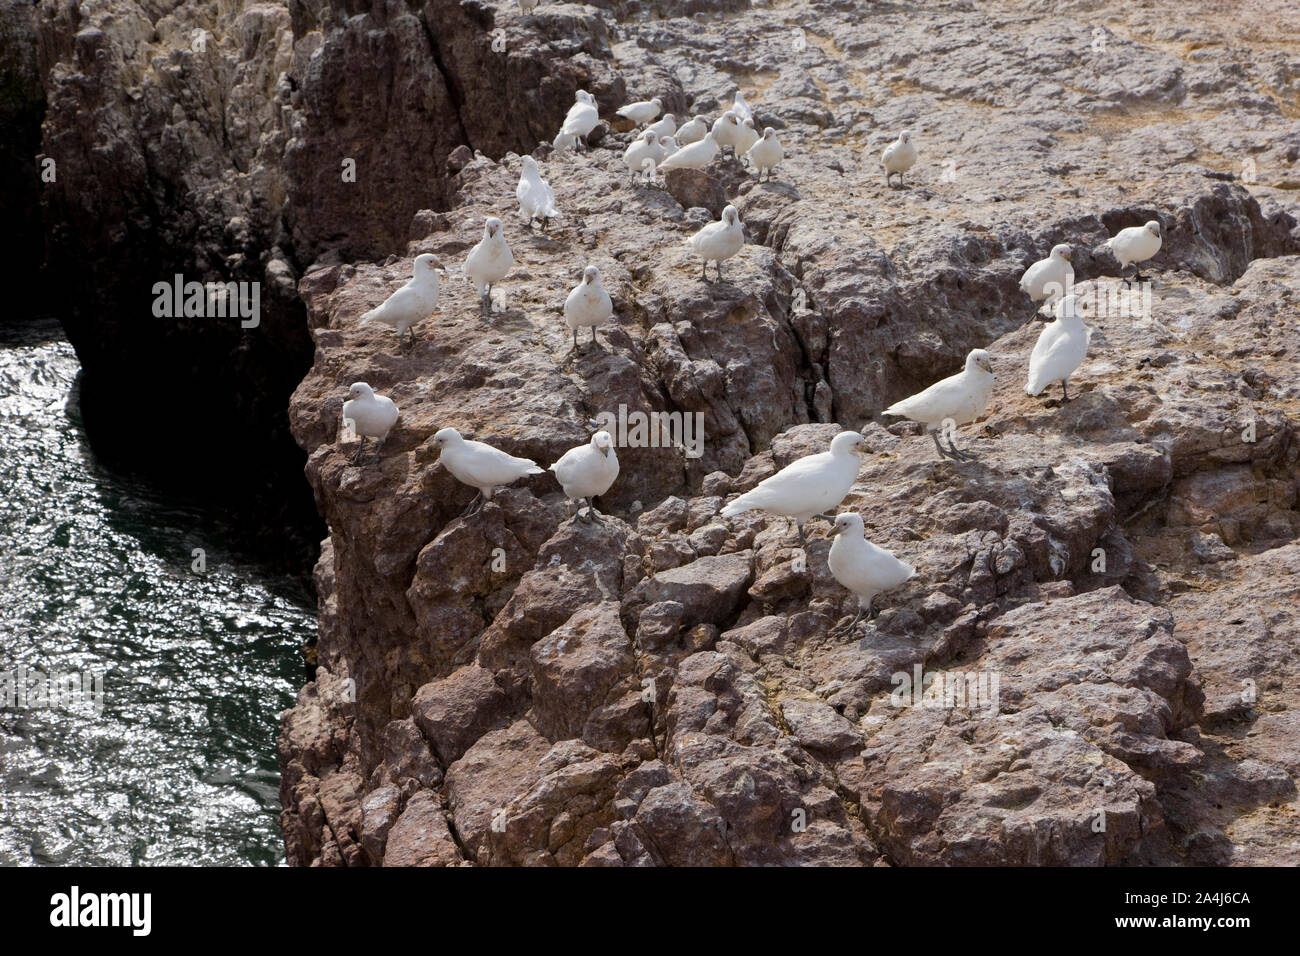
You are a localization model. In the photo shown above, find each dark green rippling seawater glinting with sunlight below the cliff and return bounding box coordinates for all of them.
[0,324,316,865]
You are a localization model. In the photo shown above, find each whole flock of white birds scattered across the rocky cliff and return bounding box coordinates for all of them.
[343,57,1180,631]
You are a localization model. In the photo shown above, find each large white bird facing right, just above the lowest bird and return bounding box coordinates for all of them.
[722,432,867,537]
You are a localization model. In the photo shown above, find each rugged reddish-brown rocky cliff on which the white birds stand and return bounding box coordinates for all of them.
[17,0,1300,865]
